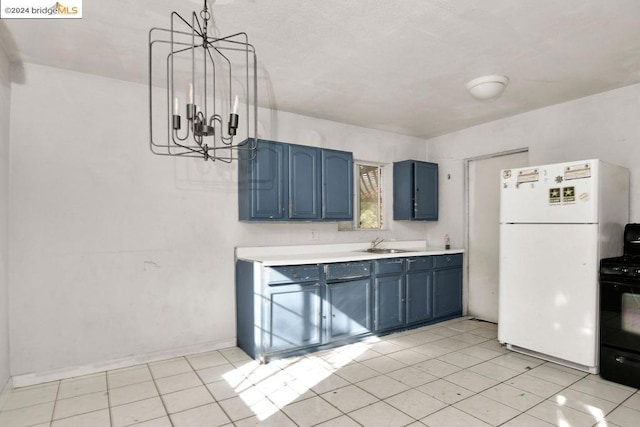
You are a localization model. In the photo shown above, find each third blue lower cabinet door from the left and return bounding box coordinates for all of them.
[373,274,404,331]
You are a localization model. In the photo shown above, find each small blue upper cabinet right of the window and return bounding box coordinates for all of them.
[393,160,438,221]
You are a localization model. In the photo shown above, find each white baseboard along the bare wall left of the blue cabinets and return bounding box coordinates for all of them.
[10,338,236,387]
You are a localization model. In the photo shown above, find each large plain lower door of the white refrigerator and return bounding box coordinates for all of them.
[498,224,598,372]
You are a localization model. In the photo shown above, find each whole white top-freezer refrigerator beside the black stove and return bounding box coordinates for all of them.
[498,159,629,373]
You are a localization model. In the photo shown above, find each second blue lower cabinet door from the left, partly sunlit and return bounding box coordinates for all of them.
[325,279,371,341]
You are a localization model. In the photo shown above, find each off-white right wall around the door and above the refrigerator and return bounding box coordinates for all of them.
[428,85,640,318]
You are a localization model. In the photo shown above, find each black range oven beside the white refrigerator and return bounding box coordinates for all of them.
[600,224,640,388]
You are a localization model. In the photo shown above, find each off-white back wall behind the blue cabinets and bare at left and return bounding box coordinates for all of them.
[9,64,427,375]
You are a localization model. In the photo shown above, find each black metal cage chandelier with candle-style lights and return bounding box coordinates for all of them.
[149,0,258,163]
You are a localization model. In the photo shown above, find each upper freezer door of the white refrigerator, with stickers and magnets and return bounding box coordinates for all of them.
[500,160,600,224]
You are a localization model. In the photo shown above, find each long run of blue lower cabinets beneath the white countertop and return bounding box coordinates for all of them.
[236,254,462,362]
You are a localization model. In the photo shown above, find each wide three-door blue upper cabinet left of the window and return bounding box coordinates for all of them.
[238,140,353,221]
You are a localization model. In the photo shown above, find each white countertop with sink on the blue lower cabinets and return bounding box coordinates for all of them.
[236,240,464,266]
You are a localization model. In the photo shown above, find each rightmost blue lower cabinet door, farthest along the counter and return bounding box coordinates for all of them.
[433,267,462,318]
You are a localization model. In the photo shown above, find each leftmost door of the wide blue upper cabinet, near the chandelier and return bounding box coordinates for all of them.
[238,140,286,220]
